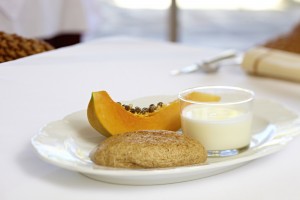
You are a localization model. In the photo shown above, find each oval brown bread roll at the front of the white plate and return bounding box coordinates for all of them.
[91,130,207,168]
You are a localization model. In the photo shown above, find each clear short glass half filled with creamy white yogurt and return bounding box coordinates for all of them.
[178,86,254,157]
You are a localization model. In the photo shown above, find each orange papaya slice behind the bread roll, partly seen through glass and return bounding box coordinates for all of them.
[87,91,219,137]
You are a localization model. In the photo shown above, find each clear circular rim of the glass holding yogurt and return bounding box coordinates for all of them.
[178,86,255,106]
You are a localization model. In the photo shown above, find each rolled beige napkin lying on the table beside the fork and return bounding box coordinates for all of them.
[242,47,300,82]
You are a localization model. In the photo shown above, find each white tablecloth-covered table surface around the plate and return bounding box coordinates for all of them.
[0,37,300,200]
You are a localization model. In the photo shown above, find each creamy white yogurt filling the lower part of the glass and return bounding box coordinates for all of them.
[181,105,252,150]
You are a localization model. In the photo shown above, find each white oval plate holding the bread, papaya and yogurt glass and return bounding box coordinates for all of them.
[32,96,300,185]
